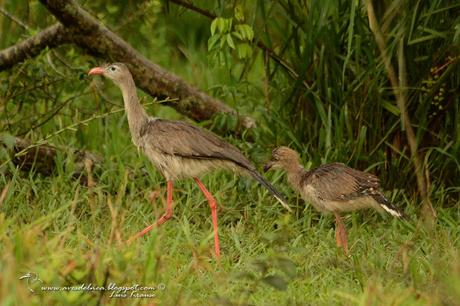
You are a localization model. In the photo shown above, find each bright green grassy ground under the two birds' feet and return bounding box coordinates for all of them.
[0,136,460,305]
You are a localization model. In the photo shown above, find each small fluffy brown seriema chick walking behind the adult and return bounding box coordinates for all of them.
[264,147,403,254]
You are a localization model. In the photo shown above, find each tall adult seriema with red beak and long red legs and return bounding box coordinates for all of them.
[88,63,291,258]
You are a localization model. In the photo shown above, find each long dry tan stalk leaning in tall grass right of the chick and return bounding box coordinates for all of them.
[364,0,436,219]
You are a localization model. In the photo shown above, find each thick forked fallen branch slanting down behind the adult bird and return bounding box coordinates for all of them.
[0,0,255,128]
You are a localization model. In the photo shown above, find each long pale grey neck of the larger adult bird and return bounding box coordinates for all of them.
[120,78,148,145]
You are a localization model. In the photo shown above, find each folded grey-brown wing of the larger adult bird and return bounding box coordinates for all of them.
[141,119,254,170]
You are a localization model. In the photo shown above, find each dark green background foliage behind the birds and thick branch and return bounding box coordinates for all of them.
[0,1,460,205]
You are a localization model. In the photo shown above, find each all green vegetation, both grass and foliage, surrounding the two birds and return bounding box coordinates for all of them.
[0,0,460,305]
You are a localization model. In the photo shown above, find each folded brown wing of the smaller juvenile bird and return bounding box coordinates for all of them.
[303,163,380,201]
